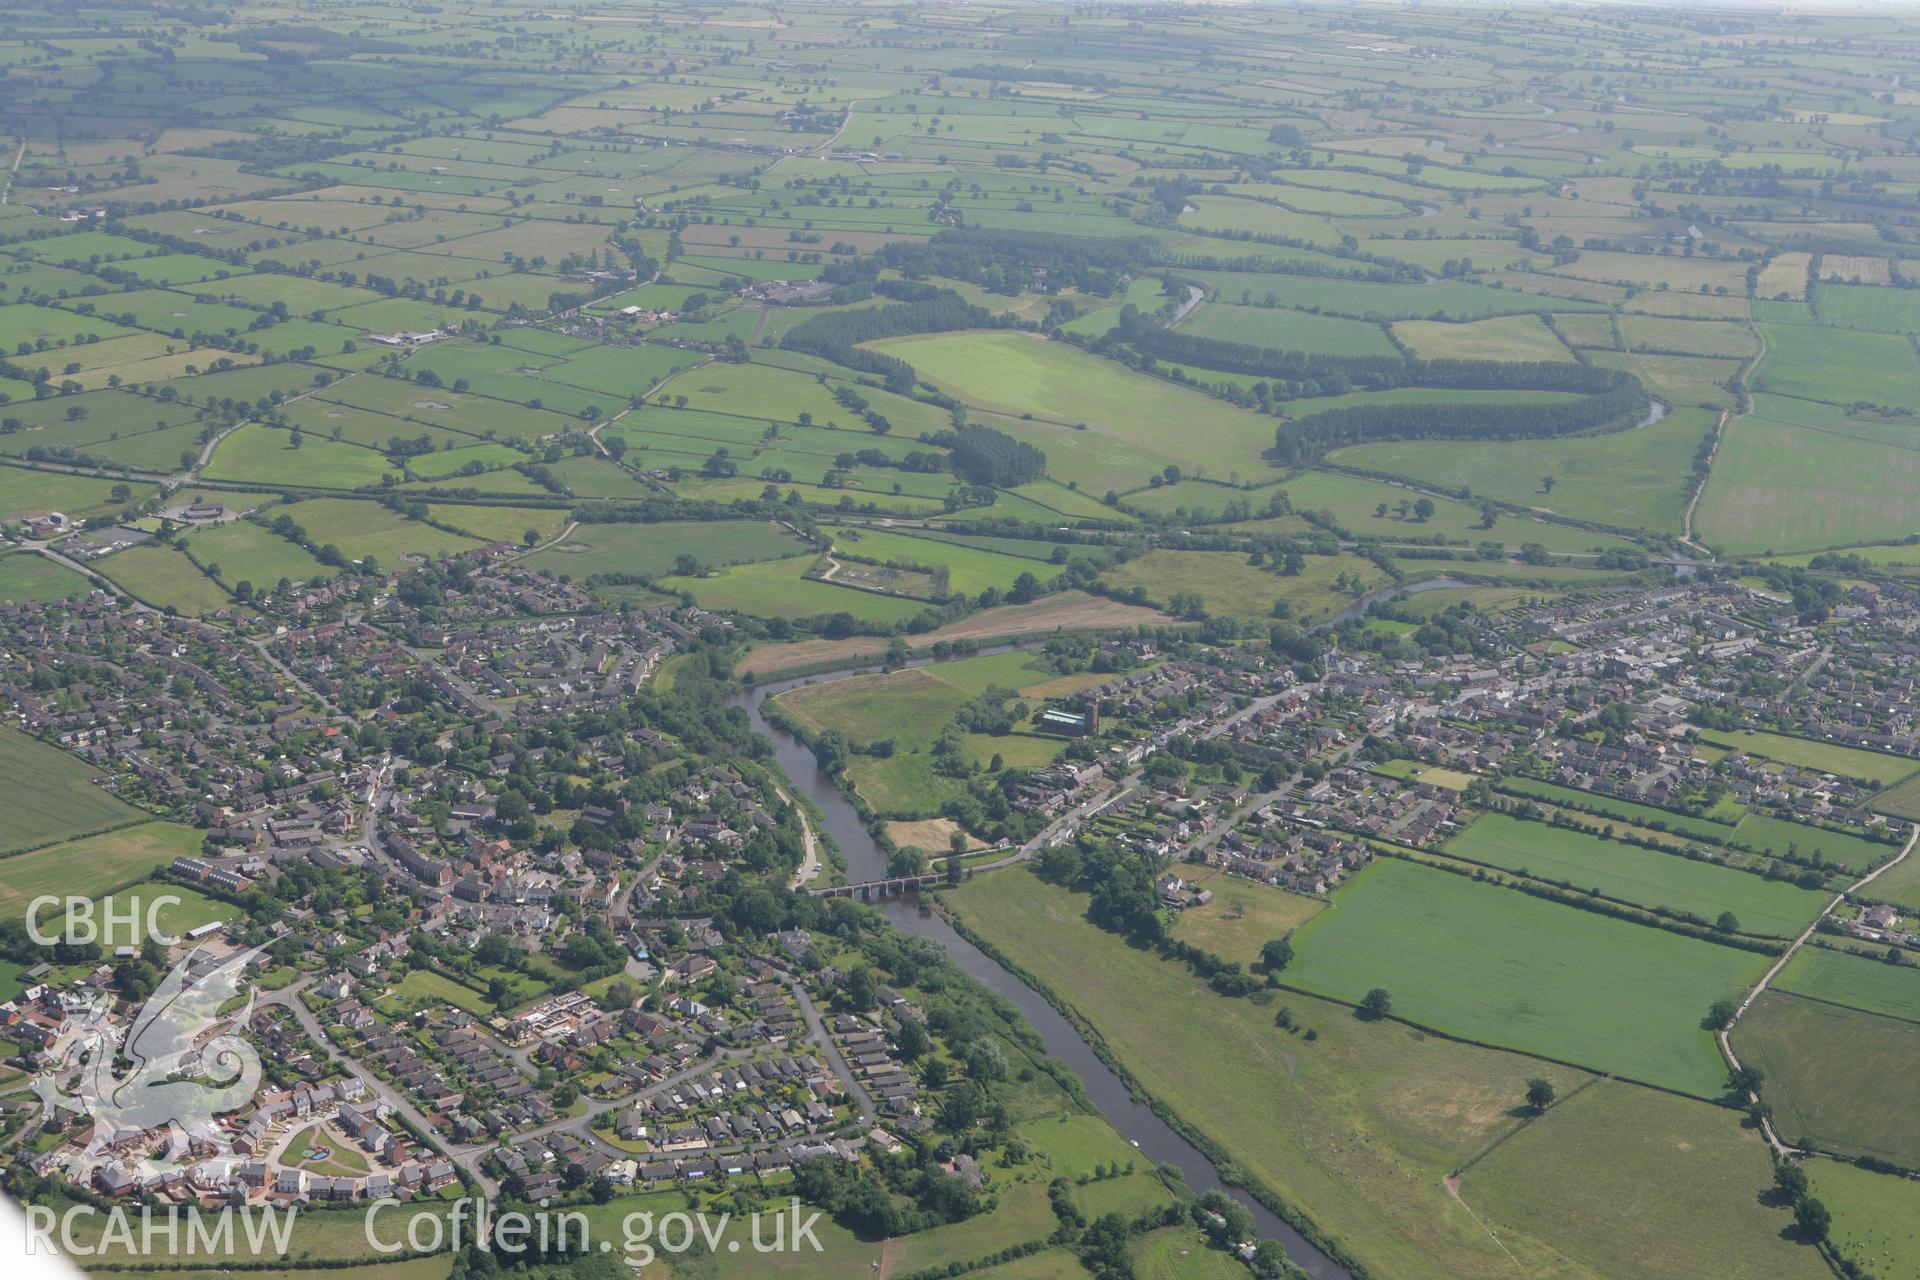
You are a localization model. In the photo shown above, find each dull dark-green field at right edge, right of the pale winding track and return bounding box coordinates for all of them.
[1734,990,1920,1169]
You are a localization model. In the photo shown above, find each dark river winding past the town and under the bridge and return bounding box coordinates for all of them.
[726,660,1348,1280]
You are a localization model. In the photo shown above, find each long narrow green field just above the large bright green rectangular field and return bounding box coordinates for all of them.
[1444,814,1828,938]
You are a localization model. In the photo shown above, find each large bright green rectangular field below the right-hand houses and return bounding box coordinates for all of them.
[1286,860,1766,1098]
